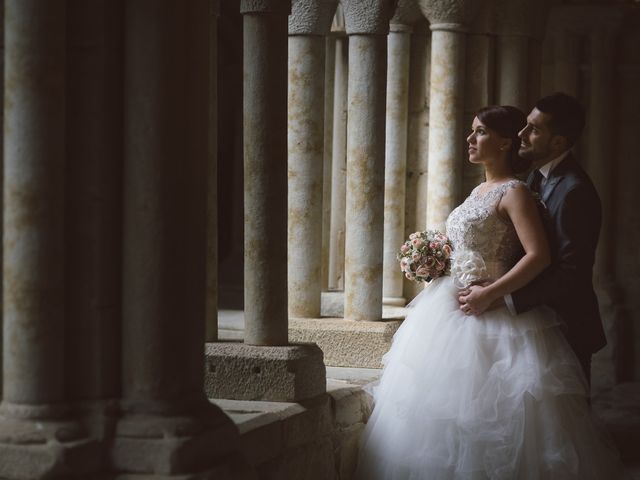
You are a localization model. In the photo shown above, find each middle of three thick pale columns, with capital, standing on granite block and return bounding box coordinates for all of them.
[343,0,395,320]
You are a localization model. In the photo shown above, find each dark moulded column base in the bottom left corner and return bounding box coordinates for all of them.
[0,403,102,480]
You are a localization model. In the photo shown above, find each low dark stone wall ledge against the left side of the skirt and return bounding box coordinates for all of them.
[211,380,371,480]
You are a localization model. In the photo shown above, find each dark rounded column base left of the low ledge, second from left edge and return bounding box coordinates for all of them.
[111,399,251,480]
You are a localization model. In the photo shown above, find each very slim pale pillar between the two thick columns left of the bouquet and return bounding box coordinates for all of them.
[329,9,349,290]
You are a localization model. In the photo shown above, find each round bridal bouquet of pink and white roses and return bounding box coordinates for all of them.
[397,230,453,282]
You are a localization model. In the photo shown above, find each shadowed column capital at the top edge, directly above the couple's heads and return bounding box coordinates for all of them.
[493,0,551,39]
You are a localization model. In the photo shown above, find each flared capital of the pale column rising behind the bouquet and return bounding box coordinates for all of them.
[418,0,487,31]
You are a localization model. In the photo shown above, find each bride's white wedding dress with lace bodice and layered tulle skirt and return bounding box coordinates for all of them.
[356,180,623,480]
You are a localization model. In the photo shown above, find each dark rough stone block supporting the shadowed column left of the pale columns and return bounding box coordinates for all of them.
[204,342,326,402]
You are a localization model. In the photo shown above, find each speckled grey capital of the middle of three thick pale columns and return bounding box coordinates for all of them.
[340,0,397,35]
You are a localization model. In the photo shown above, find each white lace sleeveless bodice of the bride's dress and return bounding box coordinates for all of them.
[447,180,522,279]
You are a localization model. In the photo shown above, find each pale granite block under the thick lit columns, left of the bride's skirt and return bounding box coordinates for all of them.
[289,318,402,368]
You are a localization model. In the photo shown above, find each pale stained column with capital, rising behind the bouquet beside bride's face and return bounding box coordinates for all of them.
[419,0,484,230]
